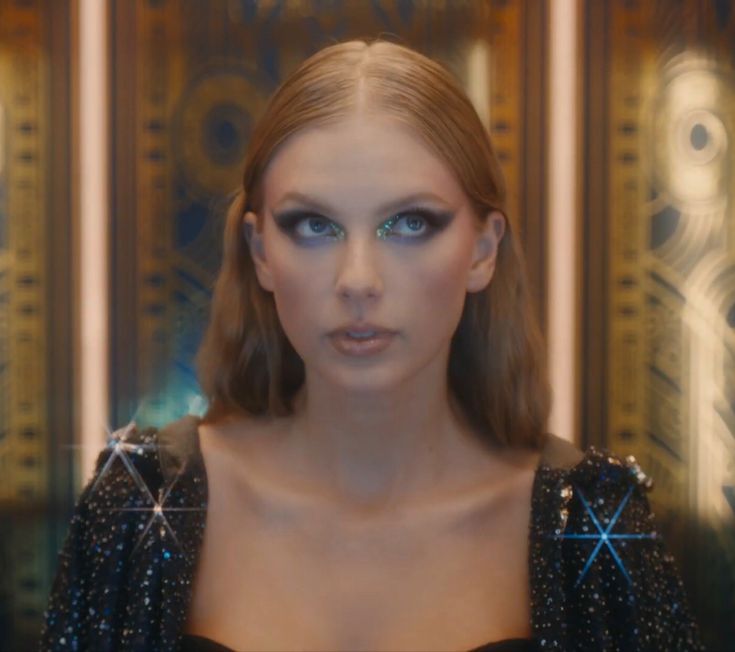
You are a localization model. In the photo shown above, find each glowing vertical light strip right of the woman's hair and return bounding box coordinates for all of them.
[547,0,579,440]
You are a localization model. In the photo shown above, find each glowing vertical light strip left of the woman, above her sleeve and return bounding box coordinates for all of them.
[78,0,109,482]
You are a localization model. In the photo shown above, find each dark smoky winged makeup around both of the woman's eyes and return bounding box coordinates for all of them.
[273,206,454,242]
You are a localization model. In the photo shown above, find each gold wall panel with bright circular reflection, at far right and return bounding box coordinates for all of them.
[583,0,735,649]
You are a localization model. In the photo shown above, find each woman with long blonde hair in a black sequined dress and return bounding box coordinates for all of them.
[42,41,700,651]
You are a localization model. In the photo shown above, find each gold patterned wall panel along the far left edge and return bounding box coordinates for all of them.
[0,0,75,650]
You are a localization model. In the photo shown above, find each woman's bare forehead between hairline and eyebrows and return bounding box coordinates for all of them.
[263,115,464,205]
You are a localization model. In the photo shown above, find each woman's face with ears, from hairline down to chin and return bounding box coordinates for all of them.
[244,115,505,391]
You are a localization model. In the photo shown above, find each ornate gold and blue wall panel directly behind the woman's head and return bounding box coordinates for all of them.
[111,0,546,424]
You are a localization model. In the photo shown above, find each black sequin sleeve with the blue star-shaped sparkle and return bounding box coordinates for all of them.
[546,449,704,652]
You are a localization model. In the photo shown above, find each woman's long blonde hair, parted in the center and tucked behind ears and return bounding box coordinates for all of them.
[196,39,551,447]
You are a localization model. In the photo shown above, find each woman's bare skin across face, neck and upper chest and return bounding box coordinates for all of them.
[186,113,538,651]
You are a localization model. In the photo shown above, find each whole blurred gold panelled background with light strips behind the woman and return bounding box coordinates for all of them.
[0,0,735,651]
